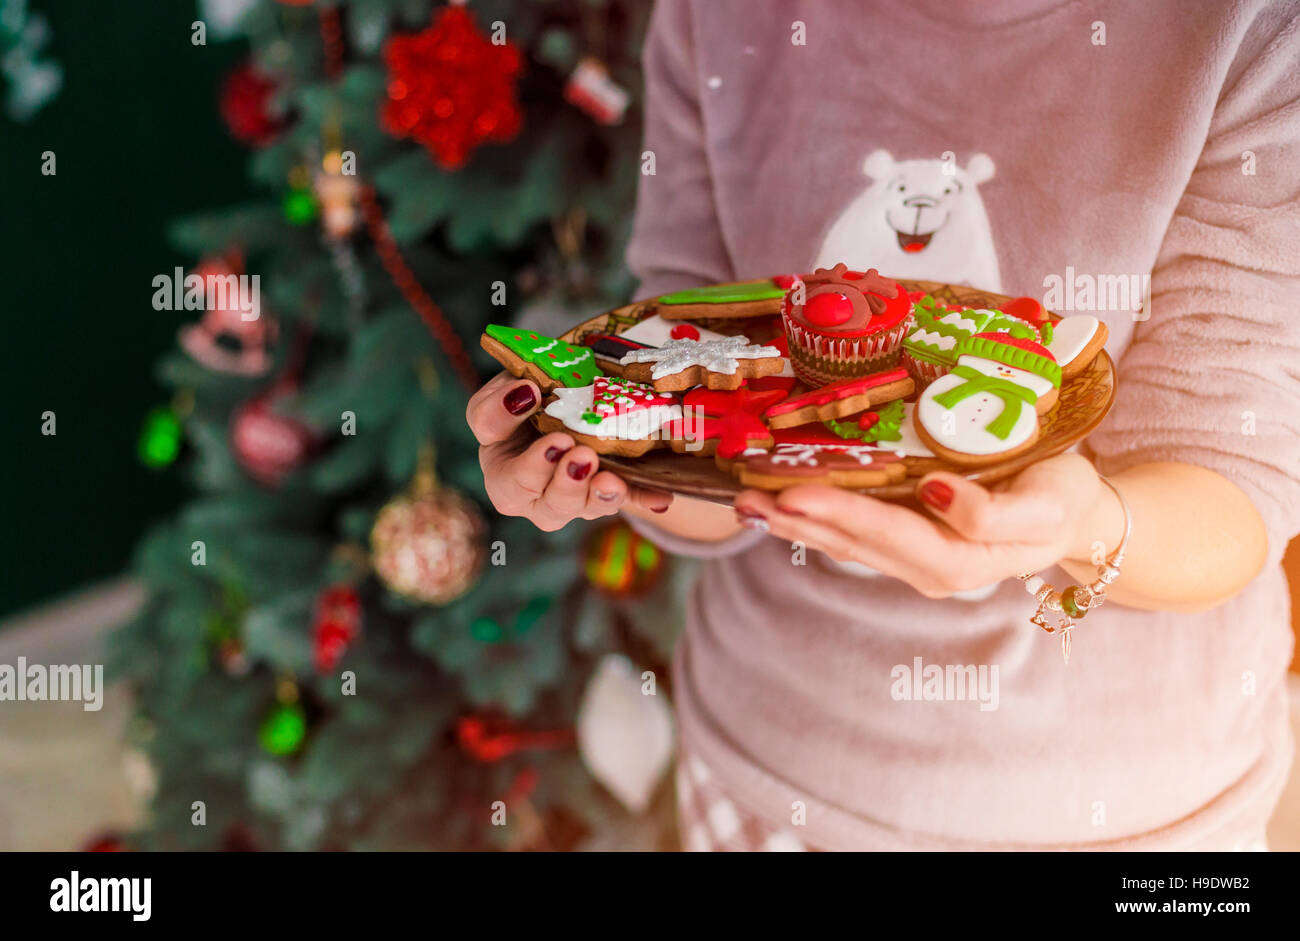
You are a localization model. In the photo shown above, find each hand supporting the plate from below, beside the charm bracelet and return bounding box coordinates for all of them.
[736,454,1113,598]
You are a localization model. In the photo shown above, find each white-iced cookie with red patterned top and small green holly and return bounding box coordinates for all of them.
[537,376,681,458]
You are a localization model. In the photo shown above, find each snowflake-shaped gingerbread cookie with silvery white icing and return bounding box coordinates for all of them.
[620,337,785,393]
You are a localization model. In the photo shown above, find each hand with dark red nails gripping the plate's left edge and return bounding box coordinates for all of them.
[465,373,672,533]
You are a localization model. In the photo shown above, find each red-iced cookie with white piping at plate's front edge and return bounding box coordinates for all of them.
[732,441,907,490]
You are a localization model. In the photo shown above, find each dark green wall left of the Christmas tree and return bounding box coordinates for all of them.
[0,0,251,615]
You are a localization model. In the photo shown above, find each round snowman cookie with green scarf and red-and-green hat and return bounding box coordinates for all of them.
[914,333,1061,465]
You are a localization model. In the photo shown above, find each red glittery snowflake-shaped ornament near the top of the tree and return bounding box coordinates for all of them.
[380,6,523,170]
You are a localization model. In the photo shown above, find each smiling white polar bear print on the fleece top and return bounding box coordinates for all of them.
[813,151,1002,294]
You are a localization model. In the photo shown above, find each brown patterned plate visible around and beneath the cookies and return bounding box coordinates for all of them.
[538,278,1115,504]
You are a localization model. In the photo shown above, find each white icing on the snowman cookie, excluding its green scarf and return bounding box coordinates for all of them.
[917,356,1056,455]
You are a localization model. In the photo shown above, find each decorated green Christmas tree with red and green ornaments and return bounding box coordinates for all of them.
[114,0,688,849]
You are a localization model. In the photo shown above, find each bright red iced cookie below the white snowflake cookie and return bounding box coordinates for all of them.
[666,377,794,460]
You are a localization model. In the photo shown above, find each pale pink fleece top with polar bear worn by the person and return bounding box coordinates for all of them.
[629,0,1300,849]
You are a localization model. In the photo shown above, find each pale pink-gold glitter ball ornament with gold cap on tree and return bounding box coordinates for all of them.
[371,452,488,604]
